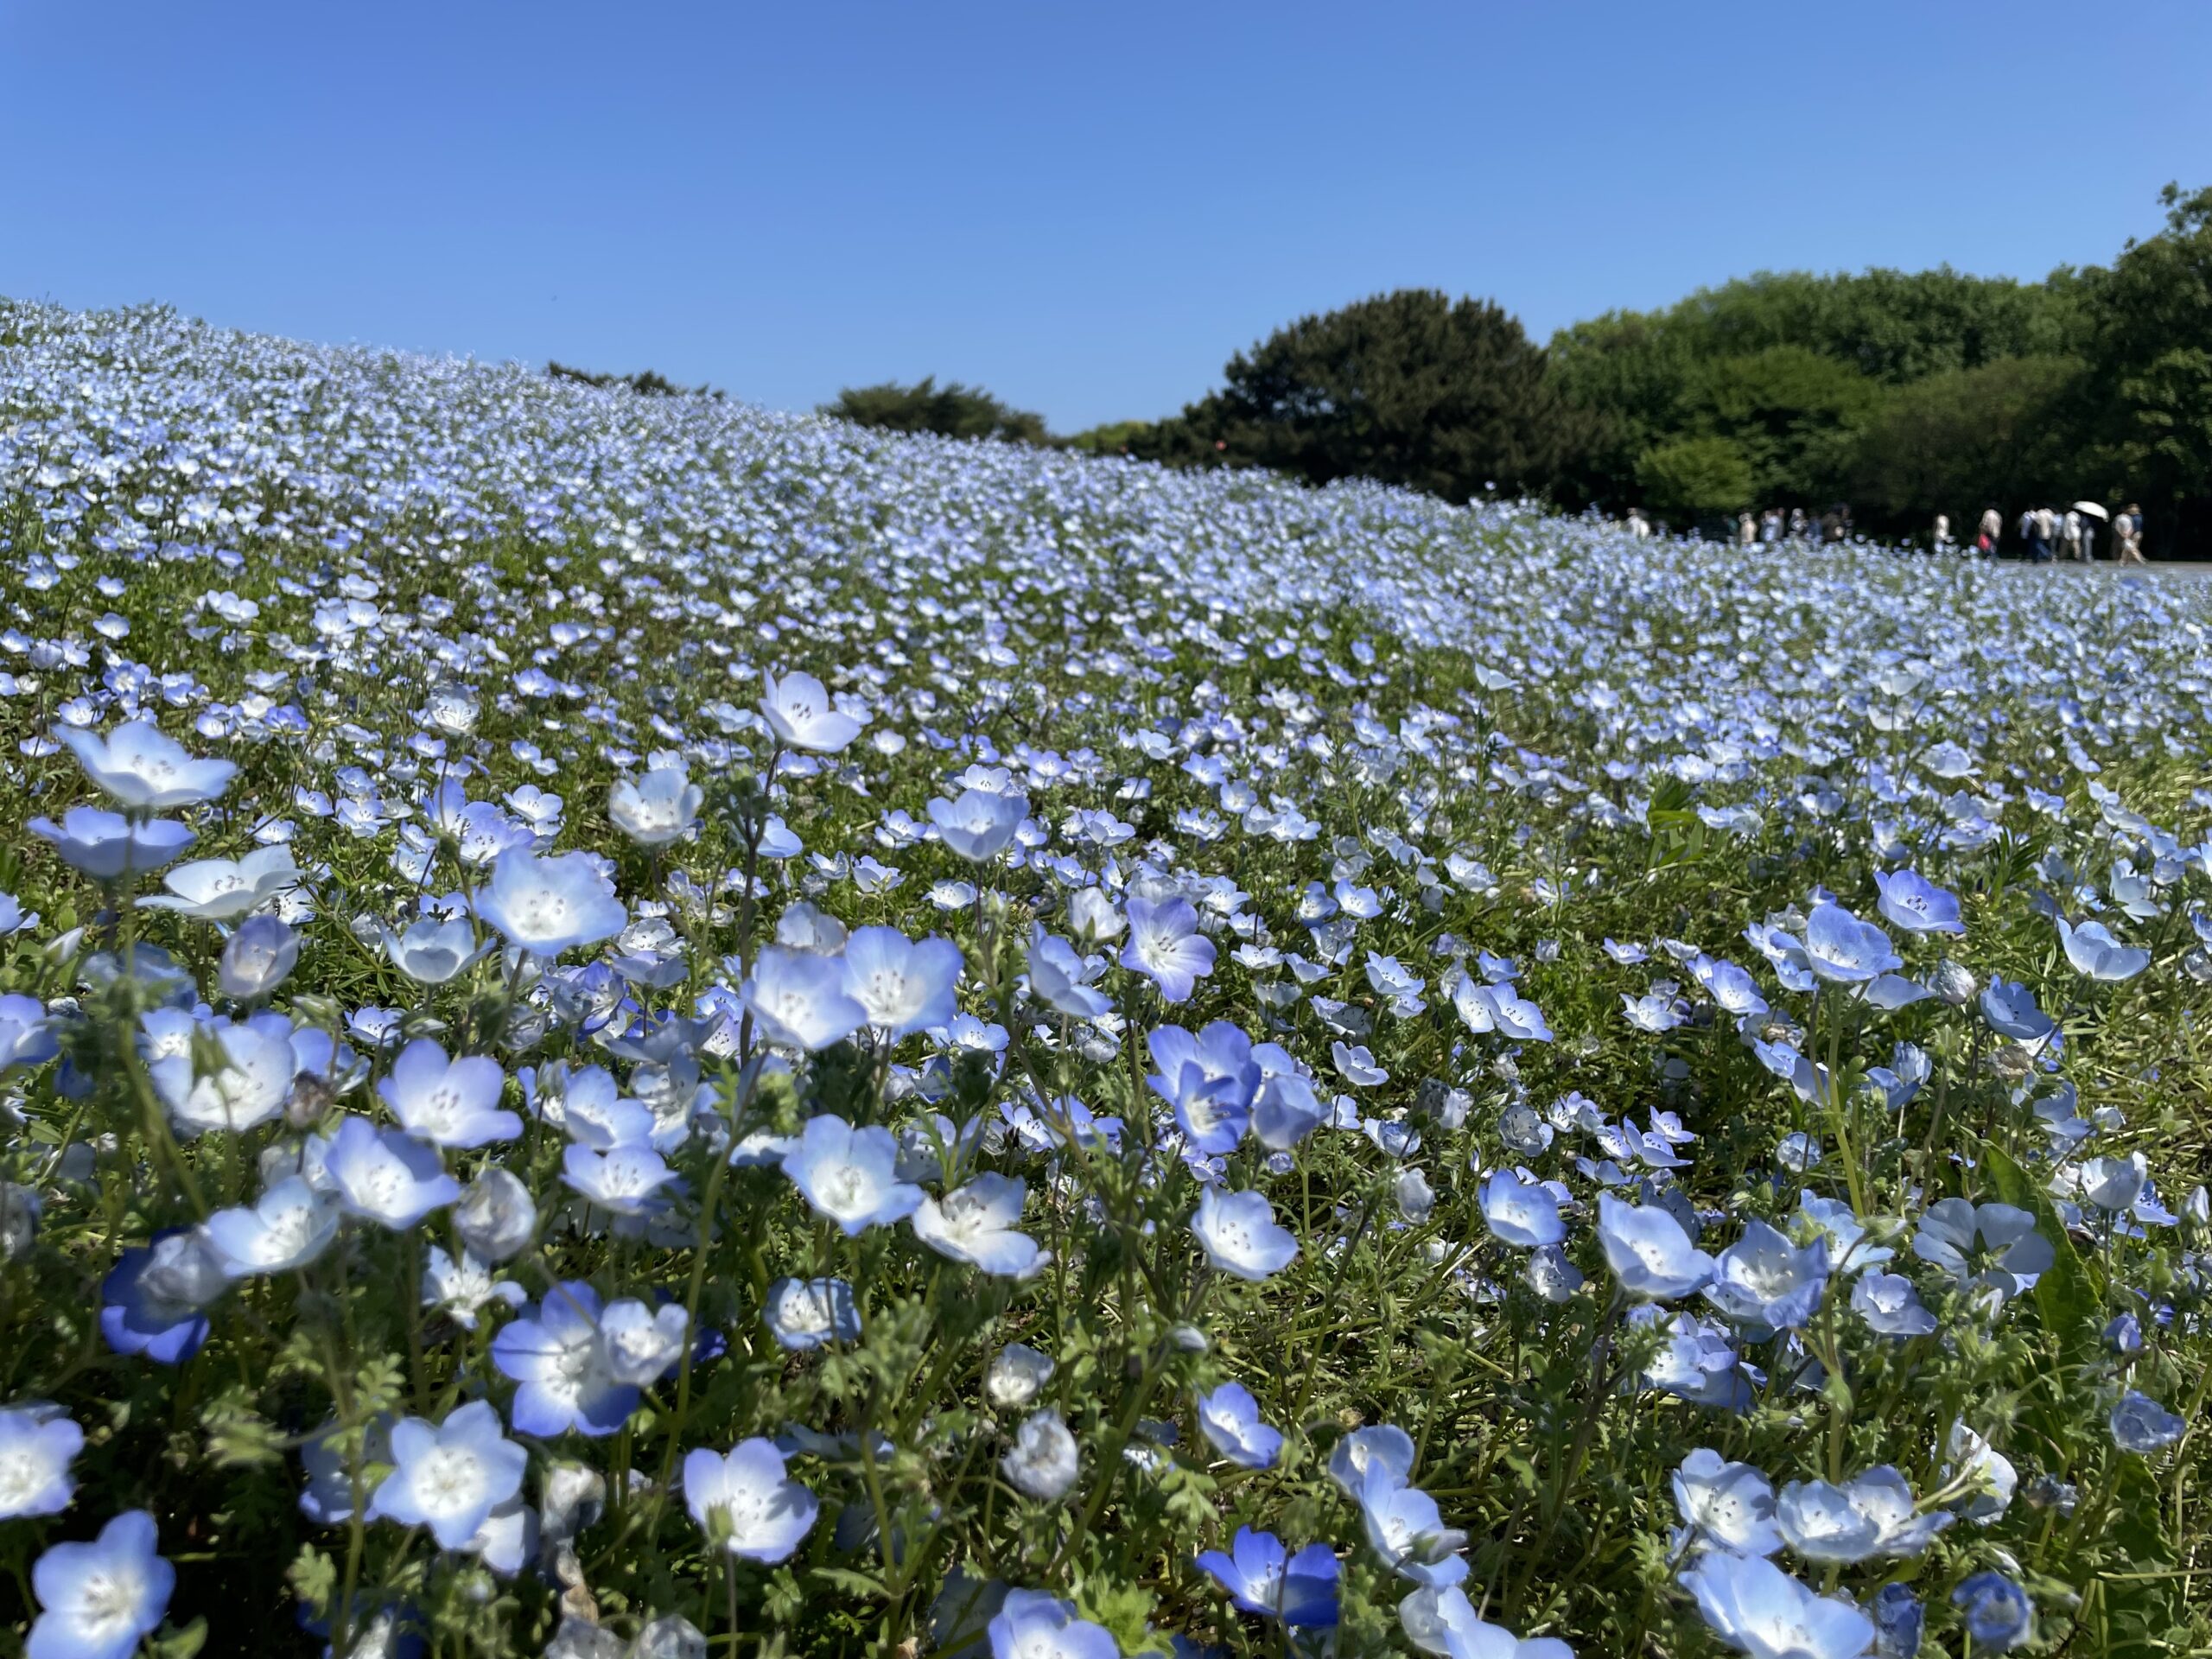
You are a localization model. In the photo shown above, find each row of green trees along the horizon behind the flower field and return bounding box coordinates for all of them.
[830,186,2212,553]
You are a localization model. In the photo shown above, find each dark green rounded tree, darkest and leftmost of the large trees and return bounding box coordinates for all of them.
[1146,288,1577,502]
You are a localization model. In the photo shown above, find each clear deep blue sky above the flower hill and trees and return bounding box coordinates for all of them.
[0,0,2212,429]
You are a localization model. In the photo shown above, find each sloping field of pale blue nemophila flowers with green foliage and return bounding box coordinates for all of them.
[0,303,2212,1659]
